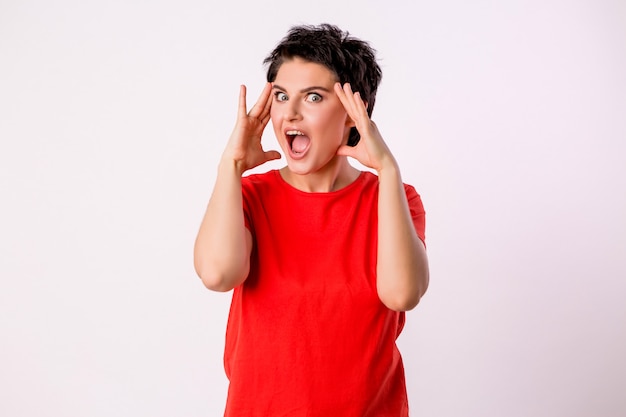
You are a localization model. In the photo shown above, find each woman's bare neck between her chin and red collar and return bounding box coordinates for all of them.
[280,156,361,193]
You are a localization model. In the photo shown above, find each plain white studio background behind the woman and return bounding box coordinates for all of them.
[0,0,626,417]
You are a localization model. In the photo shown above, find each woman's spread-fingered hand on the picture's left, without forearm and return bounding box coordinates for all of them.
[222,83,281,174]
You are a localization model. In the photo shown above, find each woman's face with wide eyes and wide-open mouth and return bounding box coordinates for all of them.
[271,58,354,175]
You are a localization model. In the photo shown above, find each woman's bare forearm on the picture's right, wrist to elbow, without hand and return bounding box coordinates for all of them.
[376,160,429,311]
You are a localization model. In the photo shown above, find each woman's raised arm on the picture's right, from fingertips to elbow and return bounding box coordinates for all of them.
[335,84,429,311]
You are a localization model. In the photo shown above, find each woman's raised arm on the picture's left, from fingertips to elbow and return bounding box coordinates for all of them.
[194,84,280,291]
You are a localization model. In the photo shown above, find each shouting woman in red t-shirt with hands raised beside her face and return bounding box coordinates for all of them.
[194,25,429,417]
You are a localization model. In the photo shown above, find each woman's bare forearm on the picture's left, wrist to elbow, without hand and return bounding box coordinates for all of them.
[194,160,251,291]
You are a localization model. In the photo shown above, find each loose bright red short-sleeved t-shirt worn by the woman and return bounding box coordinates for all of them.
[224,171,424,417]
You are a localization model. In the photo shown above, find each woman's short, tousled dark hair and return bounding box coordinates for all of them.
[263,23,382,146]
